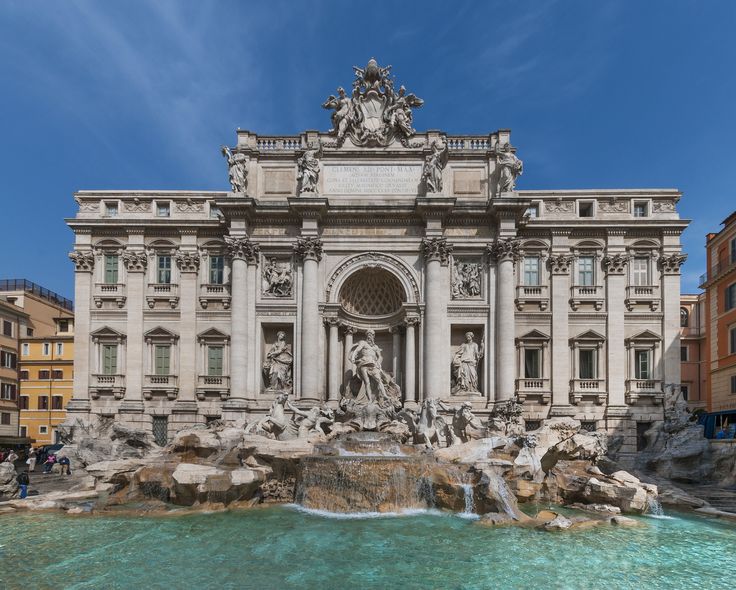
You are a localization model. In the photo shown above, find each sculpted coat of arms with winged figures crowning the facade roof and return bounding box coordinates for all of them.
[322,59,424,147]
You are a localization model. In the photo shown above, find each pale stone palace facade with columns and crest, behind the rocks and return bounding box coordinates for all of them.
[68,60,687,458]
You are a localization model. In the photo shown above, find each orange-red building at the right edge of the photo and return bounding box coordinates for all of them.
[700,211,736,431]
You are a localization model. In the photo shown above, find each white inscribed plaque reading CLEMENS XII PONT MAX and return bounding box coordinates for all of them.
[323,165,422,196]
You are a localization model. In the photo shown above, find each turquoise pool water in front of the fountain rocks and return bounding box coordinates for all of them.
[0,506,736,590]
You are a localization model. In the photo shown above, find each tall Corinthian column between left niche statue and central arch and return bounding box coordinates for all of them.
[294,238,322,400]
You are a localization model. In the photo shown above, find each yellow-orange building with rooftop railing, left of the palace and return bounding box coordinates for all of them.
[0,279,74,445]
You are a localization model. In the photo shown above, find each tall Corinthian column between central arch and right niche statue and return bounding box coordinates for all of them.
[422,238,452,398]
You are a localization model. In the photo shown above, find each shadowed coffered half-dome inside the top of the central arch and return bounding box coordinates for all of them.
[339,268,406,319]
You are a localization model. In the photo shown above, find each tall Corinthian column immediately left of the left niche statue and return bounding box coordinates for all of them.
[223,236,260,418]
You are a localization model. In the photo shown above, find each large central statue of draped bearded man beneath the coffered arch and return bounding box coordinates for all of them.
[349,330,401,406]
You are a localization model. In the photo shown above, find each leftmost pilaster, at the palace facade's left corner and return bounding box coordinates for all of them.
[66,249,95,413]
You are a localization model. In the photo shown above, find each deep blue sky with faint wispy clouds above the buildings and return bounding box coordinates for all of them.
[0,0,736,297]
